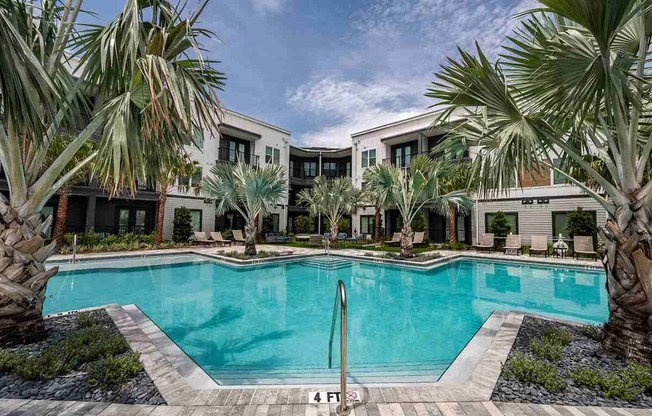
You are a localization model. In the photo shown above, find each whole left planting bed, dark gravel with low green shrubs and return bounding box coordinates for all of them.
[0,310,165,405]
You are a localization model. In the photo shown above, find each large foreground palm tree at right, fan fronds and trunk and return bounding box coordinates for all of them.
[428,0,652,358]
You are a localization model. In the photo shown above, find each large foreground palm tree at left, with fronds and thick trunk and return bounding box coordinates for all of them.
[0,0,224,338]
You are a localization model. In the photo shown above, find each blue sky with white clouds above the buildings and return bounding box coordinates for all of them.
[84,0,534,146]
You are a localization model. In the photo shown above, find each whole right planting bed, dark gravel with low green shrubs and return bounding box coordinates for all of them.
[491,316,652,407]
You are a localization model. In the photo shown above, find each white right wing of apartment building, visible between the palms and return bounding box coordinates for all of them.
[351,112,607,244]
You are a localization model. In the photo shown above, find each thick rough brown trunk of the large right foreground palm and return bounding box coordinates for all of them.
[600,205,652,360]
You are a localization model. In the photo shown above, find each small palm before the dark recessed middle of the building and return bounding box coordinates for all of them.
[297,176,362,245]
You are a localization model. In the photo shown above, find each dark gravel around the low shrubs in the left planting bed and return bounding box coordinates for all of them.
[0,310,165,405]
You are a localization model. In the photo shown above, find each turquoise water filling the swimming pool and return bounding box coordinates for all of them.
[45,257,607,384]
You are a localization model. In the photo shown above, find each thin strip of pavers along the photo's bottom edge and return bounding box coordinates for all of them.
[0,399,652,416]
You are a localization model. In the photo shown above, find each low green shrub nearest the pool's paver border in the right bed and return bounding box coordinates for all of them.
[503,354,566,392]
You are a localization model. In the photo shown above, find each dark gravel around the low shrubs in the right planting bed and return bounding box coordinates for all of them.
[491,316,652,408]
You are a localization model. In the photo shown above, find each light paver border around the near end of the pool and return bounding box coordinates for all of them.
[95,304,525,406]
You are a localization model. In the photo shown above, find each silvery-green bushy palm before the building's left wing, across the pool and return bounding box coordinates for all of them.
[202,160,287,256]
